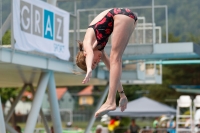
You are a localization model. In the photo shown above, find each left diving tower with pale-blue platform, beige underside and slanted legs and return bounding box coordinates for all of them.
[0,46,107,133]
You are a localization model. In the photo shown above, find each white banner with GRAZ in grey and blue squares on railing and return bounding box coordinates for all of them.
[13,0,70,60]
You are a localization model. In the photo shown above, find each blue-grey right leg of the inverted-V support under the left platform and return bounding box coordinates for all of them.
[48,71,62,133]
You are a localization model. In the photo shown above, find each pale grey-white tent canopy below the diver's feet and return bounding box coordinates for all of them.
[108,97,176,117]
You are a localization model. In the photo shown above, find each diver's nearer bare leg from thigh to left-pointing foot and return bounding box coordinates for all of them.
[95,15,135,116]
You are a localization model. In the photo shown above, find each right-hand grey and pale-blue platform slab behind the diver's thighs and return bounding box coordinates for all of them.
[105,42,200,60]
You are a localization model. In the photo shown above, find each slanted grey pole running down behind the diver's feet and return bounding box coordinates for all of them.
[84,84,109,133]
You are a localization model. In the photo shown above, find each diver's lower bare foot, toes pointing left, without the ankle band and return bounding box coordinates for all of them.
[95,103,116,117]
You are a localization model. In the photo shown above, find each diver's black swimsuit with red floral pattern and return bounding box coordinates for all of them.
[88,8,137,50]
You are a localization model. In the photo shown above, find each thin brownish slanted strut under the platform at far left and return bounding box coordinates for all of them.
[5,84,27,122]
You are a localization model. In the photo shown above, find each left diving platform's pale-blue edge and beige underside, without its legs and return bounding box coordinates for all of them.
[0,47,107,87]
